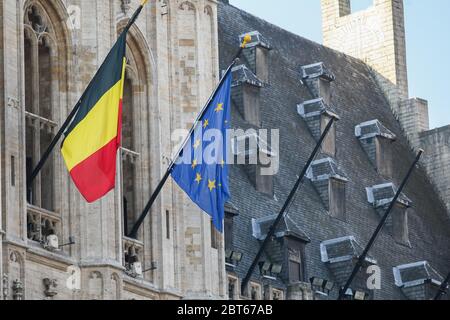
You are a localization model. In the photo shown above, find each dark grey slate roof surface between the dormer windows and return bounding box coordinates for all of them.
[218,2,450,299]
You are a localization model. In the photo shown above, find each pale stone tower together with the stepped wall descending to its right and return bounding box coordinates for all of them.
[321,0,450,214]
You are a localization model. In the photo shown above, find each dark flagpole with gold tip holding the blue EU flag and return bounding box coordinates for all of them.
[128,35,251,239]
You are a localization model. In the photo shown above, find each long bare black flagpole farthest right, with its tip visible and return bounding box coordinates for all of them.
[338,149,424,300]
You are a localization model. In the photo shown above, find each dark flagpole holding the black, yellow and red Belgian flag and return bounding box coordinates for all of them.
[27,0,148,190]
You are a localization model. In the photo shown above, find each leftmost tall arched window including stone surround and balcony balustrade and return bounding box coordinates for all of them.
[23,0,71,248]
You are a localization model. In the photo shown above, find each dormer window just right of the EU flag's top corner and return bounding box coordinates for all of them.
[231,65,263,127]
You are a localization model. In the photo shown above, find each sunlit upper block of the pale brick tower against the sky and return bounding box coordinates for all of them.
[322,0,408,111]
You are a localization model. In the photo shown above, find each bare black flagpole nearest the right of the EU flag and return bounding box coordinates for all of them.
[241,117,337,294]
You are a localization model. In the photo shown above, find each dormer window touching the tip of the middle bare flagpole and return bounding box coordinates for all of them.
[297,98,339,157]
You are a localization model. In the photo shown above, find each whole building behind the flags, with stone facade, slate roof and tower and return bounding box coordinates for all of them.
[0,0,450,300]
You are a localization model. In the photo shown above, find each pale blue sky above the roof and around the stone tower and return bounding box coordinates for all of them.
[230,0,450,128]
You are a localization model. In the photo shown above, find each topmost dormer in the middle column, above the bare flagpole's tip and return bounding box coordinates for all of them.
[300,62,335,104]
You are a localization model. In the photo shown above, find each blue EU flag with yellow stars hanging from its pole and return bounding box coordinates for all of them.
[171,71,232,232]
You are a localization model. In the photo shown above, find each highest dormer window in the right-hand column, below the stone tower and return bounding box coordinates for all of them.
[355,120,397,178]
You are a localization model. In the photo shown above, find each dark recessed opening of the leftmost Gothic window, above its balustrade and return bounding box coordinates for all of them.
[24,5,58,211]
